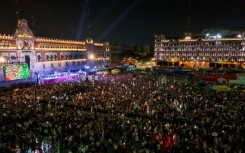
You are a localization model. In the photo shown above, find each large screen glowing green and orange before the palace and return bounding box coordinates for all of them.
[3,64,30,81]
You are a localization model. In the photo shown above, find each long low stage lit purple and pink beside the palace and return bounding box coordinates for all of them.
[41,74,80,84]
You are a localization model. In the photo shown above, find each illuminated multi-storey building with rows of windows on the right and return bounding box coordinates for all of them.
[154,34,245,68]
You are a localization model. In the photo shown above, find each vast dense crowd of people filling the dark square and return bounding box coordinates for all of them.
[0,72,245,153]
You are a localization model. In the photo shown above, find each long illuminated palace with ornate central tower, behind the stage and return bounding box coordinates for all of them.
[0,19,111,81]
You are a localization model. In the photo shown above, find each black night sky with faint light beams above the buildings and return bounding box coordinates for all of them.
[0,0,245,45]
